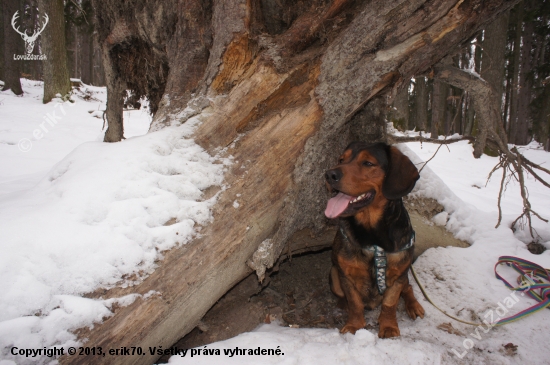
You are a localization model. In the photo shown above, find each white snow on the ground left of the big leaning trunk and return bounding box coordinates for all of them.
[0,80,229,364]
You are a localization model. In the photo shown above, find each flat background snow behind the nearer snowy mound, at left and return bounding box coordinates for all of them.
[0,79,151,196]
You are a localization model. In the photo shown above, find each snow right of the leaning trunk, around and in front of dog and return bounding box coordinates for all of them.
[170,141,550,365]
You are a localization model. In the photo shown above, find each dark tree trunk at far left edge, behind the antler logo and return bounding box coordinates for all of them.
[2,0,23,95]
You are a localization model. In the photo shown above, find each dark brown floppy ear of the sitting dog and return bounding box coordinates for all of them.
[382,146,420,200]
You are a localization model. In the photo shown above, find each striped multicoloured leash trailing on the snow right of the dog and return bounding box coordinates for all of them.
[411,256,550,326]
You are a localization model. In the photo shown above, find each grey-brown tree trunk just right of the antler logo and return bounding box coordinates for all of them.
[38,0,71,104]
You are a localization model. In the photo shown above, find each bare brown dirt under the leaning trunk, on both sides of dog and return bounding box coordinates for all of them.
[159,198,468,363]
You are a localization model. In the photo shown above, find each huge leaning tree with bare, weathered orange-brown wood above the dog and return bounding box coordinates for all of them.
[66,0,528,364]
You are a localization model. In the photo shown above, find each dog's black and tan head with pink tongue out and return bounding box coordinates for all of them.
[325,142,420,218]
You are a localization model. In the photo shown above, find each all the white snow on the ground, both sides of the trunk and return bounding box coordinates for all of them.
[0,80,550,365]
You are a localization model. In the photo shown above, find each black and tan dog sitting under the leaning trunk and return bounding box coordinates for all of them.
[325,142,424,338]
